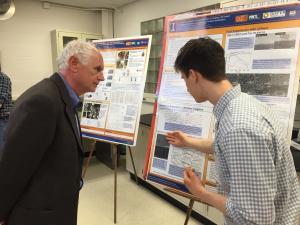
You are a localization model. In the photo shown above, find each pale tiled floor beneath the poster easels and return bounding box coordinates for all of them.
[78,156,200,225]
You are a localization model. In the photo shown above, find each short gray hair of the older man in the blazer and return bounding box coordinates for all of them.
[57,40,98,70]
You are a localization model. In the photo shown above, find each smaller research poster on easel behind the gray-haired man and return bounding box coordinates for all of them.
[81,36,151,146]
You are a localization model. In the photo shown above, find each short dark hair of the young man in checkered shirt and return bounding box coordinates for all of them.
[175,38,226,82]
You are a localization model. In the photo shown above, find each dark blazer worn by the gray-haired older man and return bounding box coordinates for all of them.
[0,73,83,225]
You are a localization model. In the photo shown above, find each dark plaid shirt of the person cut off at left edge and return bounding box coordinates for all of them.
[0,72,12,119]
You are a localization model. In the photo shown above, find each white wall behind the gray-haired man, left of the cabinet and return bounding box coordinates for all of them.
[0,0,101,98]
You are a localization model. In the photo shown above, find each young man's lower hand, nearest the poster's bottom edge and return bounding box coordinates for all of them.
[184,167,207,198]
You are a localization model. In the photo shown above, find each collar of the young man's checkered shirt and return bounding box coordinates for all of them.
[213,84,241,121]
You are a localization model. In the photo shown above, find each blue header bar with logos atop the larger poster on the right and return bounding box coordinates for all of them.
[169,5,300,33]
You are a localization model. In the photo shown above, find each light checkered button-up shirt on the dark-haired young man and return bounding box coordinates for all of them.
[213,85,300,225]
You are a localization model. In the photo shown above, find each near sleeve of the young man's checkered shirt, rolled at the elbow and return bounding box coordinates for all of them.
[221,129,276,225]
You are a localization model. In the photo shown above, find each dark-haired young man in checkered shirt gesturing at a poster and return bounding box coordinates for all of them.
[167,38,300,225]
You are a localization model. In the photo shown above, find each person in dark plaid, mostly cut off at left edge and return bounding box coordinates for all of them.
[0,62,12,155]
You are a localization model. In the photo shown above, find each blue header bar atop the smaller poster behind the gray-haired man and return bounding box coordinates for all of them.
[95,38,149,49]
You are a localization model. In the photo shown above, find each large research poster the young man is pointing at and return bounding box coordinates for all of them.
[144,1,300,191]
